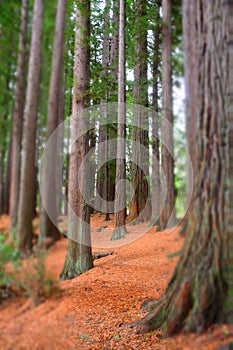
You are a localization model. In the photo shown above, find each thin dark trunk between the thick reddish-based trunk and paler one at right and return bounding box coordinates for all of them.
[150,1,161,225]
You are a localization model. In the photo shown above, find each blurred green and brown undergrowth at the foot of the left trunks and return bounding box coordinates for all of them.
[0,233,60,305]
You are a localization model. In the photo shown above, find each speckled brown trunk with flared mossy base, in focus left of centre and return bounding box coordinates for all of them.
[60,0,93,280]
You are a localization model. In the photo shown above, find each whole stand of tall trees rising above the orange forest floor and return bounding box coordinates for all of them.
[0,0,233,335]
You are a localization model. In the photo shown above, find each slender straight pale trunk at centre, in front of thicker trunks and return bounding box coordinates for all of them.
[111,0,127,240]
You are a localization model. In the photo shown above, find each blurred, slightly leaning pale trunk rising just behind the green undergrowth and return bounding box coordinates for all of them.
[18,0,44,253]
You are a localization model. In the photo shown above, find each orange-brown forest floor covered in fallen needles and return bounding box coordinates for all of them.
[0,215,233,350]
